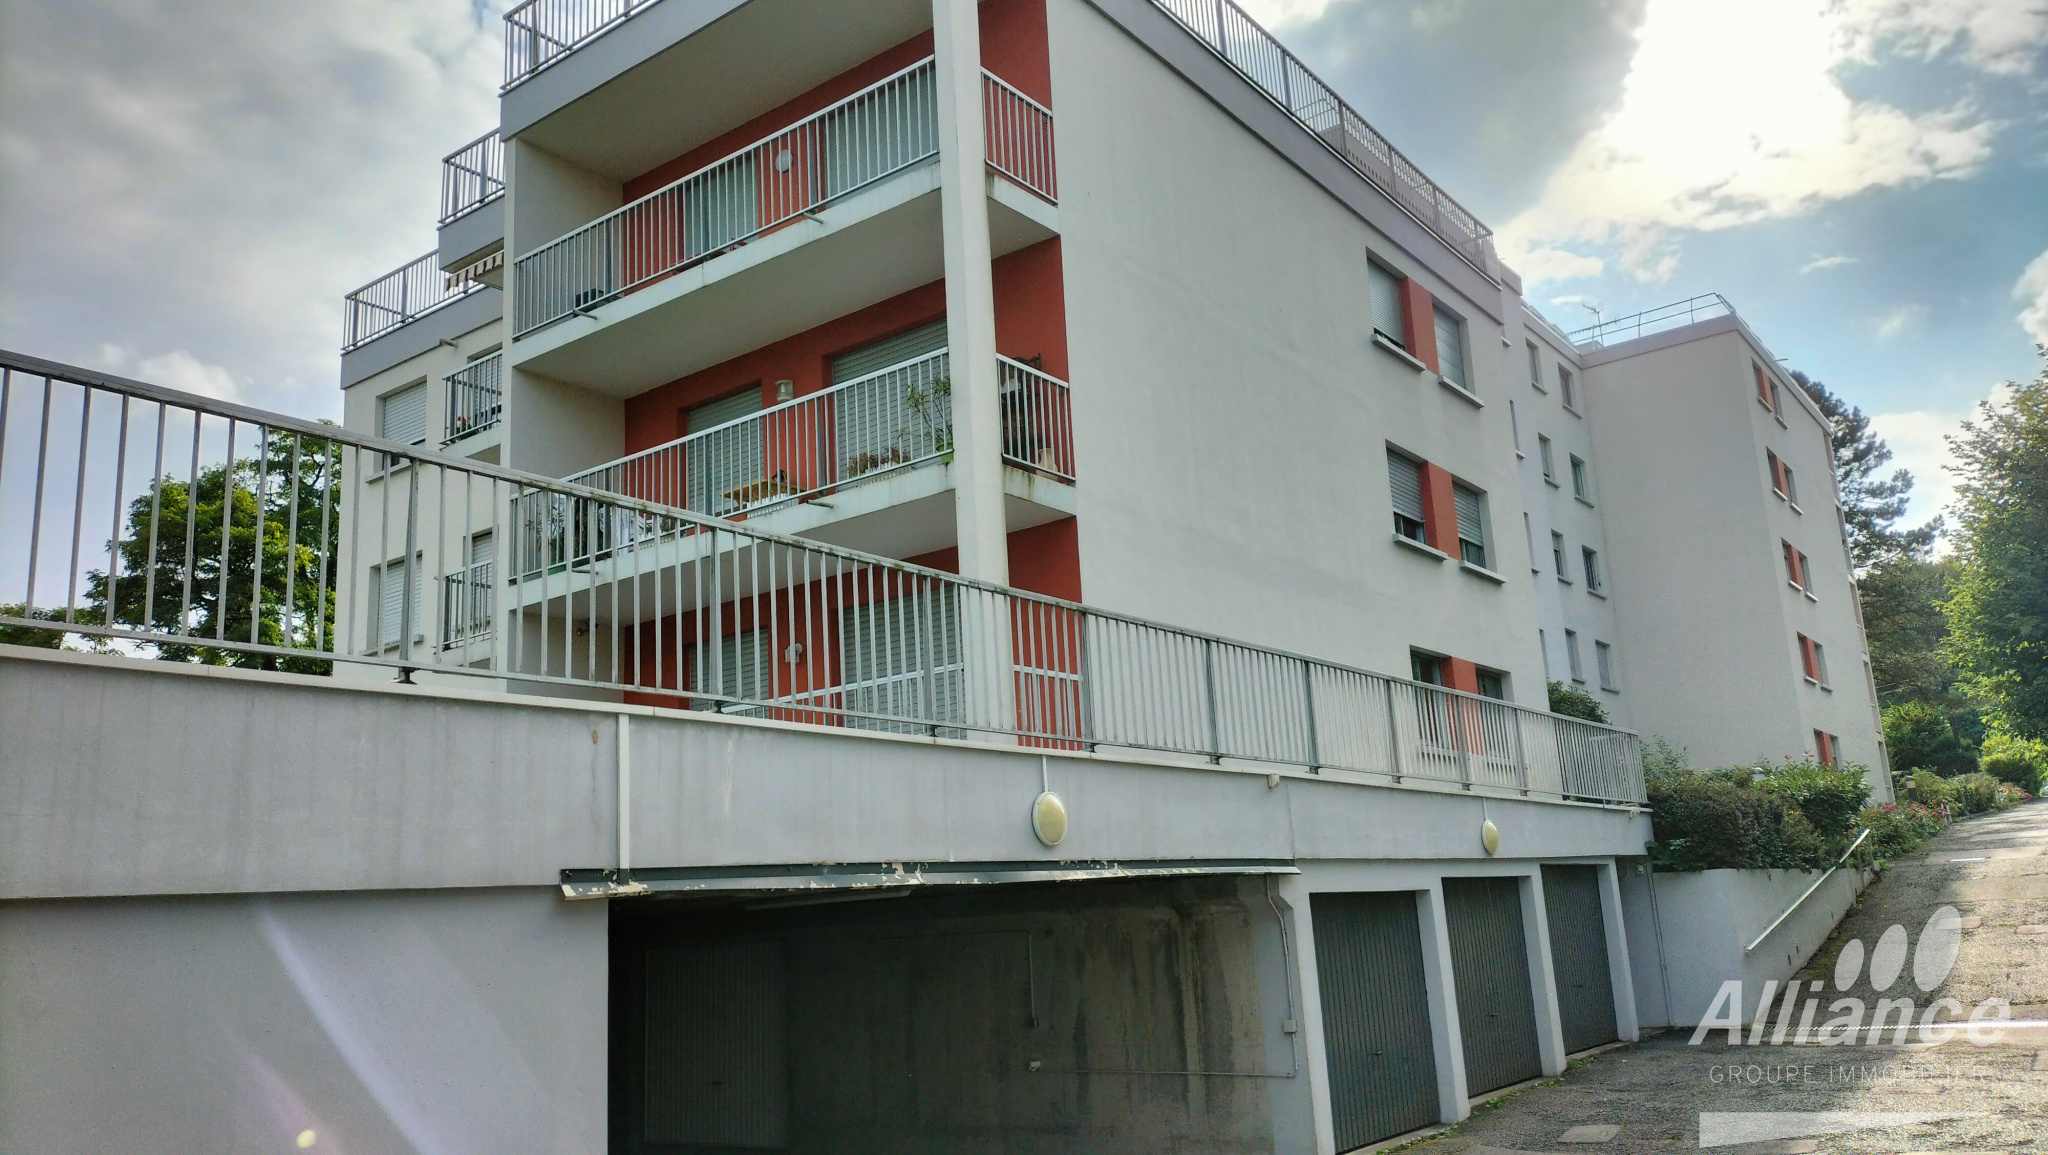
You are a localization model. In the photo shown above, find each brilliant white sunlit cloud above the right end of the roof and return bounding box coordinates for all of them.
[1501,0,1995,281]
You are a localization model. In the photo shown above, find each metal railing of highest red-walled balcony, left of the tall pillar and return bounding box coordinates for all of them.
[512,57,938,336]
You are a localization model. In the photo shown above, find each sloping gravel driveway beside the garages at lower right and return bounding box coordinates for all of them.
[1405,803,2048,1155]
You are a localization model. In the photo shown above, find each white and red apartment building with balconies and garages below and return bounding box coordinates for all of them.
[0,0,1882,1153]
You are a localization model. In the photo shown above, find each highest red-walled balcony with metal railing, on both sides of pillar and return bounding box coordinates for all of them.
[512,57,1057,395]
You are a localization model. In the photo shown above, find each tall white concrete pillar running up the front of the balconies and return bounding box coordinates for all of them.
[932,0,1010,586]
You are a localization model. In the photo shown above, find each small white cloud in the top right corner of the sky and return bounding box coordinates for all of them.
[1837,0,2048,76]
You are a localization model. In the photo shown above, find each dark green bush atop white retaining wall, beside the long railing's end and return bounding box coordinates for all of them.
[1649,774,1829,870]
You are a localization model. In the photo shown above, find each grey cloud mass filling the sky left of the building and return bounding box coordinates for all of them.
[0,0,502,416]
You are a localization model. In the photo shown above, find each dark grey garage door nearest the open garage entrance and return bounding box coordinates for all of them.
[1309,891,1440,1151]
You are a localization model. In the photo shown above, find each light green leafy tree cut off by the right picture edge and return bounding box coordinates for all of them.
[1944,346,2048,739]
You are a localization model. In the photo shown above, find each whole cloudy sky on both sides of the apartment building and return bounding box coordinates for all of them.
[0,0,2048,520]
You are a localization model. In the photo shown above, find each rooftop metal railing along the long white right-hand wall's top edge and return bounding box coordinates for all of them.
[1153,0,1501,281]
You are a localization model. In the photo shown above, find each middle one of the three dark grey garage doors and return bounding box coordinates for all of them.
[1444,879,1542,1096]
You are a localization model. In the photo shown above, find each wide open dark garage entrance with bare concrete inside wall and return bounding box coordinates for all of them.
[610,874,1294,1155]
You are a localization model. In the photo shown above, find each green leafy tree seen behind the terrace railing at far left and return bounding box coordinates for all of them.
[86,432,340,674]
